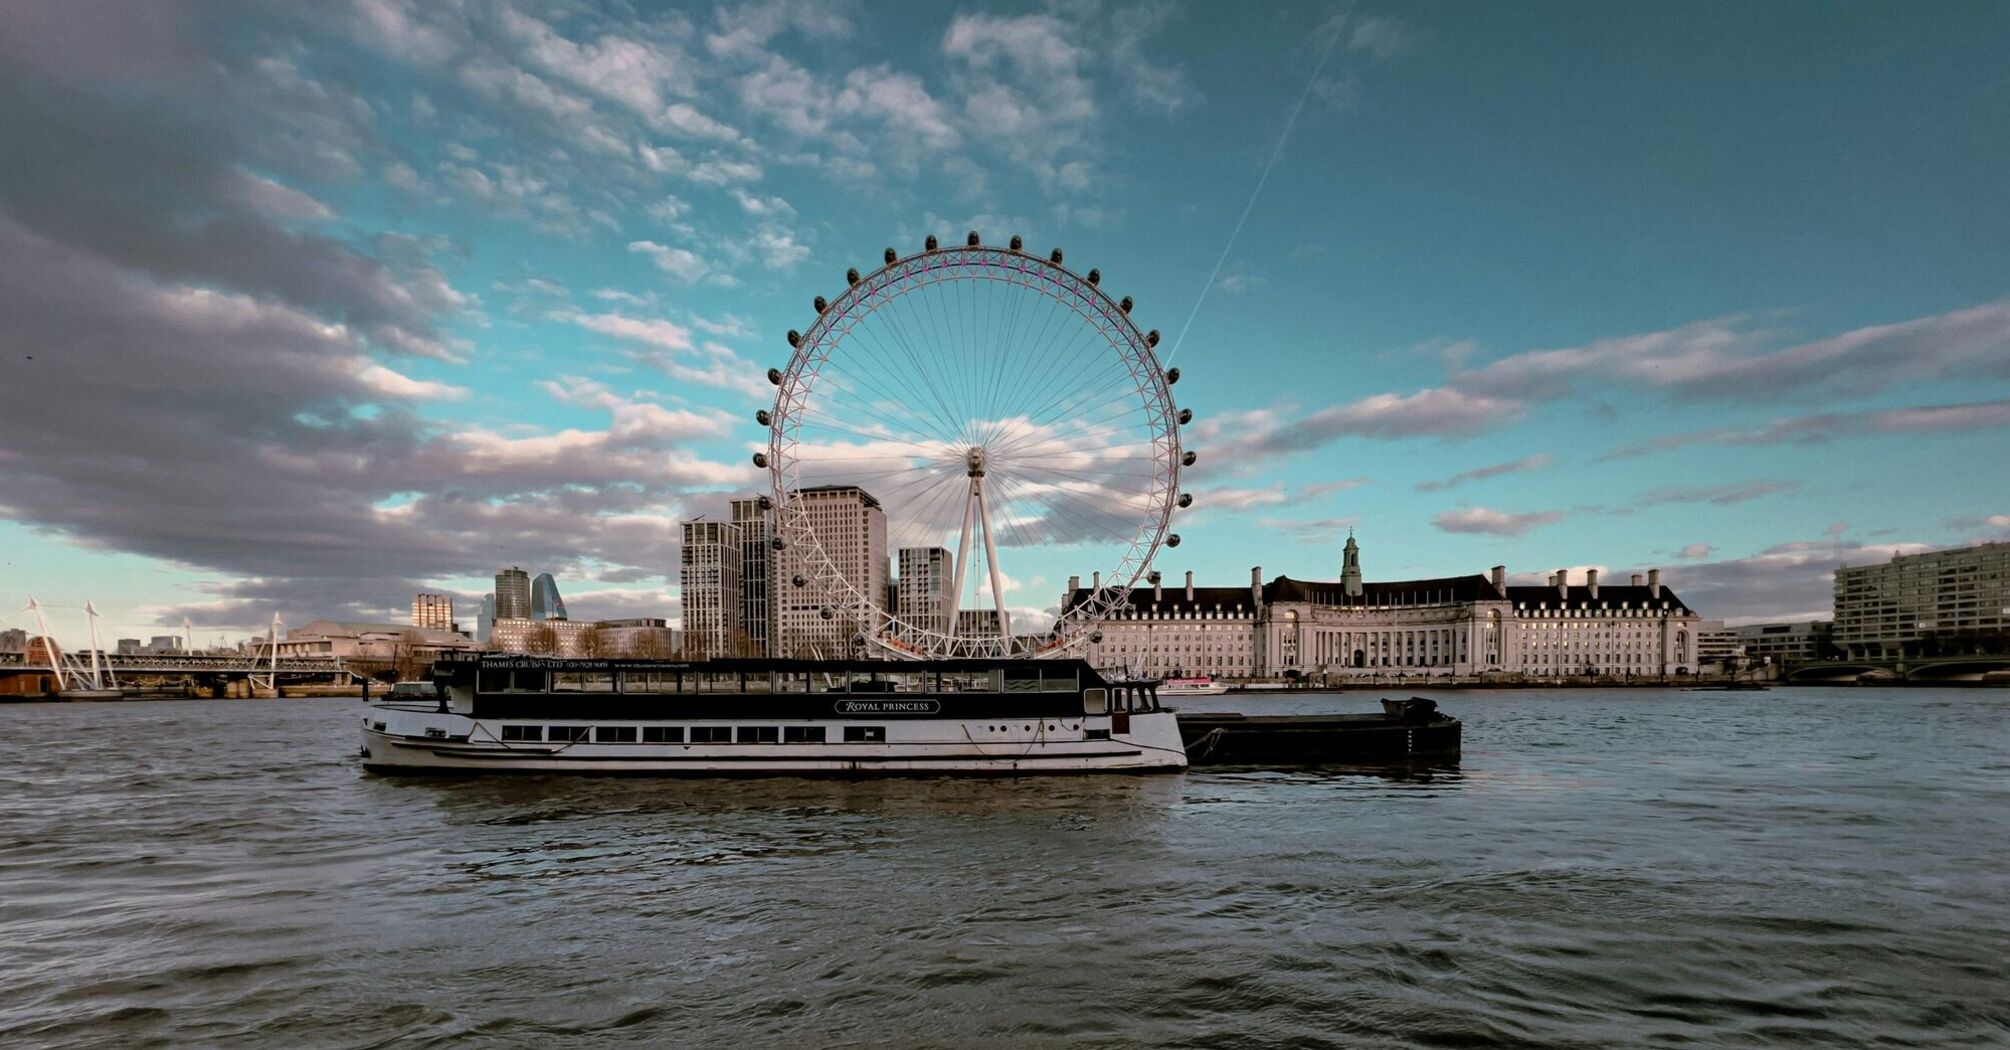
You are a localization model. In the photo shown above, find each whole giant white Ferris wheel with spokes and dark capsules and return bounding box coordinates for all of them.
[754,231,1194,658]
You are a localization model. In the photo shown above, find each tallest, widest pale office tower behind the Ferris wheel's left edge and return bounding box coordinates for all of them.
[774,485,886,656]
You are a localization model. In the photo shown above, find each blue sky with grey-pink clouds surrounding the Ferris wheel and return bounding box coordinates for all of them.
[0,0,2010,634]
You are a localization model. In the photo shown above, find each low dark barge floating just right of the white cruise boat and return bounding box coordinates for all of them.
[1180,696,1461,766]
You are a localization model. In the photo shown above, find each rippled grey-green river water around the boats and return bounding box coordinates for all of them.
[0,688,2010,1048]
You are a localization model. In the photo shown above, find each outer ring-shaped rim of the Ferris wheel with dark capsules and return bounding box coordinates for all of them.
[764,233,1192,656]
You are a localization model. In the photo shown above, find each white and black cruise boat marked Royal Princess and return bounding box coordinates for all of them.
[362,656,1186,774]
